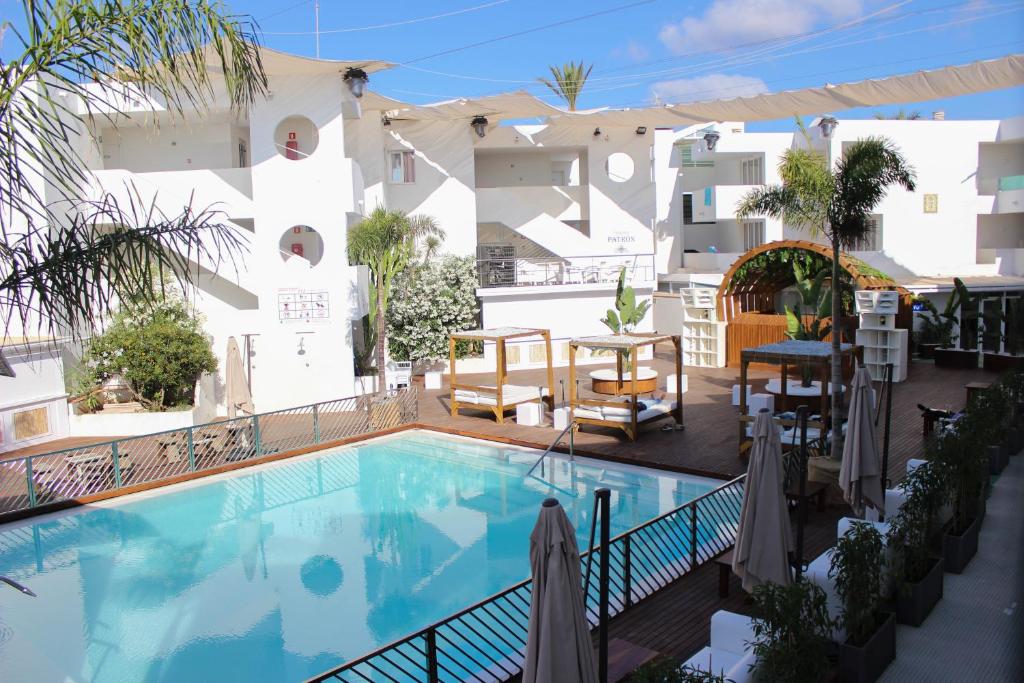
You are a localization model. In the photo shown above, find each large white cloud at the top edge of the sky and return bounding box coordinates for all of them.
[658,0,863,54]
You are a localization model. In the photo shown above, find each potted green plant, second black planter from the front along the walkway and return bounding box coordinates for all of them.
[887,464,946,626]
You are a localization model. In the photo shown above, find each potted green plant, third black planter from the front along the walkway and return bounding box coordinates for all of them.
[929,430,989,573]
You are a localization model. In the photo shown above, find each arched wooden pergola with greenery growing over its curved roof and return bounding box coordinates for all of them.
[718,240,913,367]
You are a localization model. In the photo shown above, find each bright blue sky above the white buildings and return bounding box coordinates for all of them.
[8,0,1024,130]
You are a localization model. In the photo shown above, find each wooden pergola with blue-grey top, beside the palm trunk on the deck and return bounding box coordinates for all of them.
[739,339,862,455]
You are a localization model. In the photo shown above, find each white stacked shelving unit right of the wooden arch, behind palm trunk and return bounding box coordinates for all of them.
[856,290,908,382]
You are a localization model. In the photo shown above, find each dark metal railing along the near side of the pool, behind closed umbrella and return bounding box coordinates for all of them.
[309,475,746,683]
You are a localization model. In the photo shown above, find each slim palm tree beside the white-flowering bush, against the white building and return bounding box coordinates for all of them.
[347,207,444,391]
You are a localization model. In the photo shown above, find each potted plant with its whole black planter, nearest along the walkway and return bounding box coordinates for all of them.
[828,522,896,683]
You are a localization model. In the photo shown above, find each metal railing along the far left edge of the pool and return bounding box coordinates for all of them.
[0,387,417,514]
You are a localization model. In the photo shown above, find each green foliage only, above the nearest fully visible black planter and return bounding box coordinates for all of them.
[828,522,885,646]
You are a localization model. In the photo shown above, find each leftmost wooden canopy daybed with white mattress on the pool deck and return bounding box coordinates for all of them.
[449,328,555,424]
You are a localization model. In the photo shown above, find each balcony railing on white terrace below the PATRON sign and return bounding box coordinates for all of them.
[476,254,655,288]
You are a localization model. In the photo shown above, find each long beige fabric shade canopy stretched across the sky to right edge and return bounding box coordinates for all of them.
[362,54,1024,128]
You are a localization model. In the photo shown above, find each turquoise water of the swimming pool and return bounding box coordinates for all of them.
[0,432,717,682]
